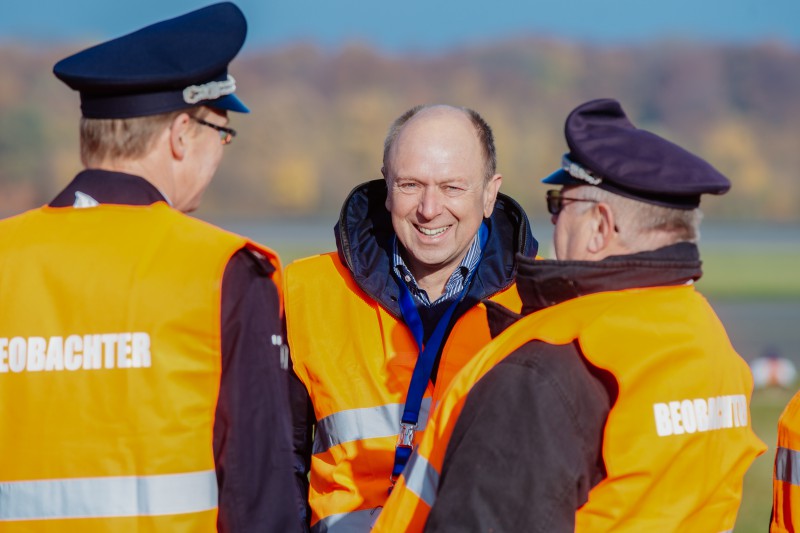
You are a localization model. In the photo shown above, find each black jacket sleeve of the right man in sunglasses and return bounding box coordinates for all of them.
[425,341,611,533]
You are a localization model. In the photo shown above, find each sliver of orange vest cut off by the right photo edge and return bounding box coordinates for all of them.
[770,392,800,533]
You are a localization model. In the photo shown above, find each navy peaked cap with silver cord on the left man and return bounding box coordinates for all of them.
[53,2,249,118]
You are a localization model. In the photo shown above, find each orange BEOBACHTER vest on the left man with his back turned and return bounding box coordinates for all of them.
[0,202,280,533]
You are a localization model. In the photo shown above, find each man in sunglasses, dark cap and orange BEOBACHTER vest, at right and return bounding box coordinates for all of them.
[374,99,765,532]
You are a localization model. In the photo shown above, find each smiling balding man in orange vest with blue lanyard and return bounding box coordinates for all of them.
[286,105,537,532]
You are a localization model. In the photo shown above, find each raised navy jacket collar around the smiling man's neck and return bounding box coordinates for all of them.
[334,179,538,318]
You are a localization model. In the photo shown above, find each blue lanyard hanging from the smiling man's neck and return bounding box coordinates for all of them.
[389,223,489,484]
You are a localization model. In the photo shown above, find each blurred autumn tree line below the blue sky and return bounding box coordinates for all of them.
[0,38,800,222]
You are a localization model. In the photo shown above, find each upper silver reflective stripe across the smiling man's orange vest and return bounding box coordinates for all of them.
[313,397,431,454]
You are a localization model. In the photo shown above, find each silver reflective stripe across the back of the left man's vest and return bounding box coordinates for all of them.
[0,470,217,520]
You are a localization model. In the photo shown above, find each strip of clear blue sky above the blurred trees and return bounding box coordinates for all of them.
[0,0,800,52]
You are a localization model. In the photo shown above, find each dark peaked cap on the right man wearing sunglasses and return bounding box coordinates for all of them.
[542,99,731,209]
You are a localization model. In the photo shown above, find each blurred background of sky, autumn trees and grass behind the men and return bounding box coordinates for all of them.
[0,0,800,532]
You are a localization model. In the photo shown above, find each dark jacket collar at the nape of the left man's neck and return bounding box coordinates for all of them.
[49,169,167,207]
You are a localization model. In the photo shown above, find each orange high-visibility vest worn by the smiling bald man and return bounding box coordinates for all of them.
[285,253,521,531]
